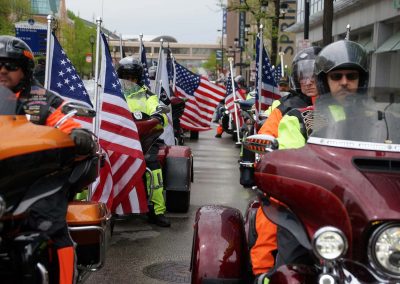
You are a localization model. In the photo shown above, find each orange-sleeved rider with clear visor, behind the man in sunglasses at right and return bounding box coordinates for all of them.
[250,47,321,282]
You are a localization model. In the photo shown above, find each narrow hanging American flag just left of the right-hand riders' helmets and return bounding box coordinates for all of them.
[256,37,281,111]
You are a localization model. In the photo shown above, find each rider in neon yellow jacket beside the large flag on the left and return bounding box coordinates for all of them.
[117,57,171,227]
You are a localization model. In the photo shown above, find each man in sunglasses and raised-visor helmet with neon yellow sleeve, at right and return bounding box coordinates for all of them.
[278,40,369,149]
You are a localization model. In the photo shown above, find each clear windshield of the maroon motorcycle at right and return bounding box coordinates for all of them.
[310,88,400,152]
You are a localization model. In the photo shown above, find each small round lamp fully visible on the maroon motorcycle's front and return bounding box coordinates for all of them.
[312,226,347,260]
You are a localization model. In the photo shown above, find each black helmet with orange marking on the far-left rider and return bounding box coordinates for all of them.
[0,36,35,83]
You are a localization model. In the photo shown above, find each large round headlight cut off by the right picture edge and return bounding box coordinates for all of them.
[369,223,400,278]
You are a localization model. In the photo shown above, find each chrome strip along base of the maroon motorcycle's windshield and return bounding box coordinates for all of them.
[307,137,400,152]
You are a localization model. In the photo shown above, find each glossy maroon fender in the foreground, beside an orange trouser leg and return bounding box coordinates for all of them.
[191,205,249,284]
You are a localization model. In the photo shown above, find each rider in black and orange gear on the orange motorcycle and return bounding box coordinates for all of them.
[0,36,96,283]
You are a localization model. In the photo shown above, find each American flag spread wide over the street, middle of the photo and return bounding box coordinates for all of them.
[175,62,225,131]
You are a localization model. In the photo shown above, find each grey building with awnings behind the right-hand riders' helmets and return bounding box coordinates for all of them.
[287,0,400,87]
